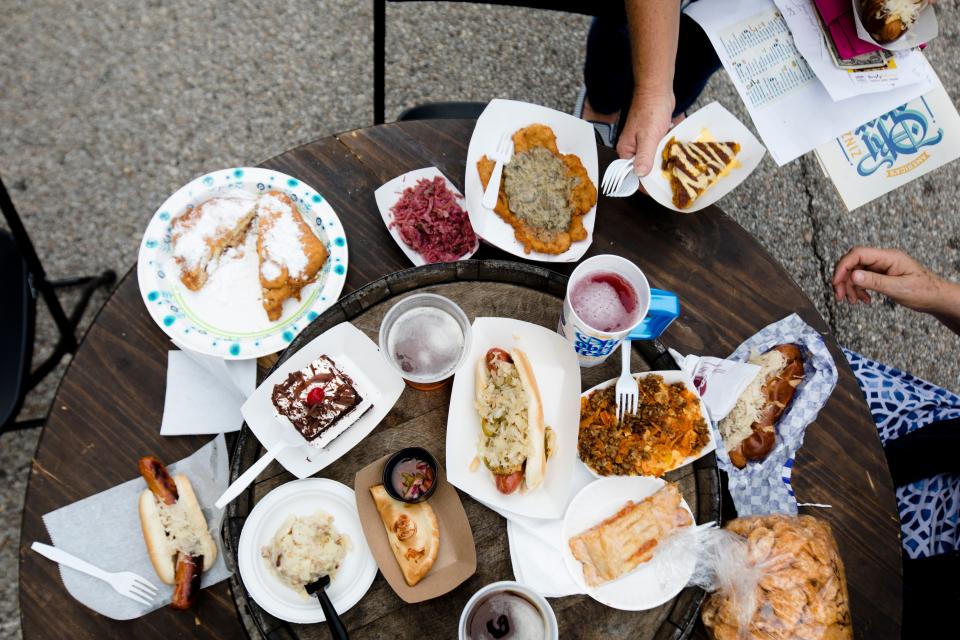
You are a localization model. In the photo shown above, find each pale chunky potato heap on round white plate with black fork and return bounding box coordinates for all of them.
[261,511,350,595]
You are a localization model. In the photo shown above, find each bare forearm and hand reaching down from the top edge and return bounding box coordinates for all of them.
[617,0,680,176]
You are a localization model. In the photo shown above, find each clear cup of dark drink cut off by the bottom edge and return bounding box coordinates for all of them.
[458,580,560,640]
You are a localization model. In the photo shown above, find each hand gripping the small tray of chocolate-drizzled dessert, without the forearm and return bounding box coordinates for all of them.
[617,92,676,177]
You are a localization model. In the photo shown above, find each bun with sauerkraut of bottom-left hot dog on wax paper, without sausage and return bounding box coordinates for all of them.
[139,475,217,584]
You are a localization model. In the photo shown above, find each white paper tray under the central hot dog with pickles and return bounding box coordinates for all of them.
[447,318,580,518]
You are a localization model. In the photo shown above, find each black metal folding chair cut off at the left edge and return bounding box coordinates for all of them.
[0,180,117,433]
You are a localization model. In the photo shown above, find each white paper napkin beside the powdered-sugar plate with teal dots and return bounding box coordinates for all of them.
[160,349,257,436]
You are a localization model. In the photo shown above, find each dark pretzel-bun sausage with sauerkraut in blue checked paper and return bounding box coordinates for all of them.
[720,344,803,469]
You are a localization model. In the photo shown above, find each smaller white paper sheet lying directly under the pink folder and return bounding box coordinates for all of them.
[774,0,926,101]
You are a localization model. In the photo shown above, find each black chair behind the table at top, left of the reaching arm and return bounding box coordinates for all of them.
[373,0,604,124]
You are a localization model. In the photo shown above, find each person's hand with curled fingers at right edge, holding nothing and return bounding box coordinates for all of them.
[833,247,945,312]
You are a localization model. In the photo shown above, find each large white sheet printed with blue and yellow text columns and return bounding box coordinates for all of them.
[685,0,934,166]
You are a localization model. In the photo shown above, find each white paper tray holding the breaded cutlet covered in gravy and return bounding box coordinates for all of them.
[464,99,600,262]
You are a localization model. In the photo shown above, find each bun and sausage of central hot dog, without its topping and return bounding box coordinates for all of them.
[475,349,547,493]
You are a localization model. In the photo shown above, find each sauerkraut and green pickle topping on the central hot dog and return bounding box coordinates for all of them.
[474,360,530,475]
